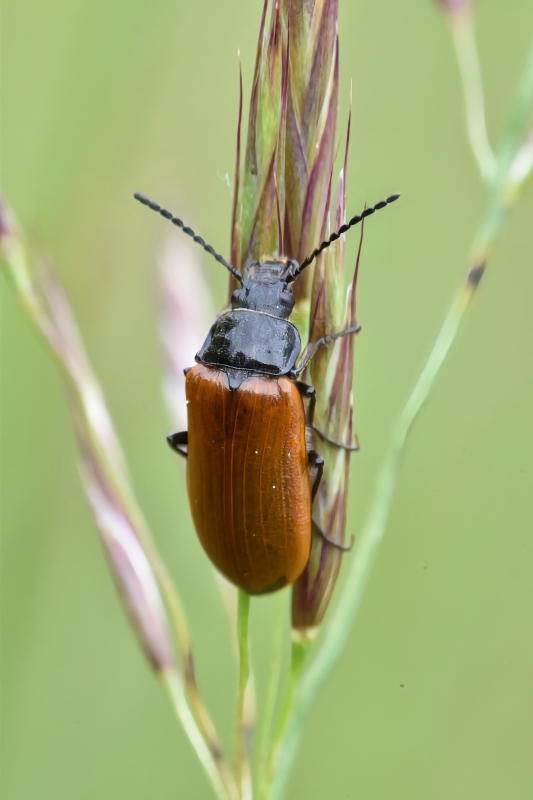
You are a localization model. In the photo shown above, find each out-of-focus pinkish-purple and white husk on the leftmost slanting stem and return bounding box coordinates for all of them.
[2,209,175,670]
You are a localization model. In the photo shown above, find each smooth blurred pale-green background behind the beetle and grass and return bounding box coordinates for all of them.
[1,0,533,800]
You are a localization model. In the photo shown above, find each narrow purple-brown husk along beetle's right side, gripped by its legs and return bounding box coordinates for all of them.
[292,108,363,636]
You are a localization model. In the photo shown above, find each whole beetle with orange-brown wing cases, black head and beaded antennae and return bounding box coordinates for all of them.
[134,193,400,594]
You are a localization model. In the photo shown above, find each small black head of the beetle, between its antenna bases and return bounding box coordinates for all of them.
[231,260,300,319]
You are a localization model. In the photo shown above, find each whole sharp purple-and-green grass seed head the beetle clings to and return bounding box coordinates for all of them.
[230,0,355,628]
